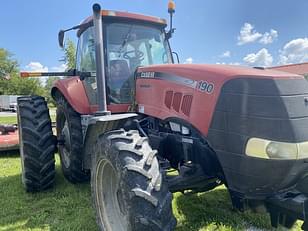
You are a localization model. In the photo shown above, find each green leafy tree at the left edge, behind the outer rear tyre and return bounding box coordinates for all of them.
[0,48,44,95]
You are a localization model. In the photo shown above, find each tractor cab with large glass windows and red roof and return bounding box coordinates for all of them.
[76,11,173,105]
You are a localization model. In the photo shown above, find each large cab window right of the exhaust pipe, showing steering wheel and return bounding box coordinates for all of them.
[105,23,172,103]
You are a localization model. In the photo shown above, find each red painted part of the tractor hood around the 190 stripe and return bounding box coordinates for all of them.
[136,64,303,135]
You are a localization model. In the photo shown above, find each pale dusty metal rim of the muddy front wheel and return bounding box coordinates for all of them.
[95,159,128,231]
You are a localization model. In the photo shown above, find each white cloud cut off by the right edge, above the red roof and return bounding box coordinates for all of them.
[279,38,308,64]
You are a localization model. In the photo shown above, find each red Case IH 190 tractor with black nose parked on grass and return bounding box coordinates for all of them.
[18,2,308,231]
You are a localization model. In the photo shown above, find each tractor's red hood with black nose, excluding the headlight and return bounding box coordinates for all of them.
[136,64,308,198]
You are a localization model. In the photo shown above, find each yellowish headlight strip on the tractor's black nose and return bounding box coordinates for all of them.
[245,138,308,160]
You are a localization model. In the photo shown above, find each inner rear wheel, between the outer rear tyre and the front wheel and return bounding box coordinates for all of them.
[56,95,90,183]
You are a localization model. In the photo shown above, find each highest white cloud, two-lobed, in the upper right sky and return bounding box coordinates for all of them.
[237,22,278,45]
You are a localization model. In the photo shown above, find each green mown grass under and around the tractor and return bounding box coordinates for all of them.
[0,117,300,231]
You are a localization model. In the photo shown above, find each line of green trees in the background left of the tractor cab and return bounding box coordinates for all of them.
[0,40,76,104]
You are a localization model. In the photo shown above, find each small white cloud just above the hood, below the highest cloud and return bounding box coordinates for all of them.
[243,48,273,67]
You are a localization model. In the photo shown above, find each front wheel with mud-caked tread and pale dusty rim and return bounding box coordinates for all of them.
[91,130,176,231]
